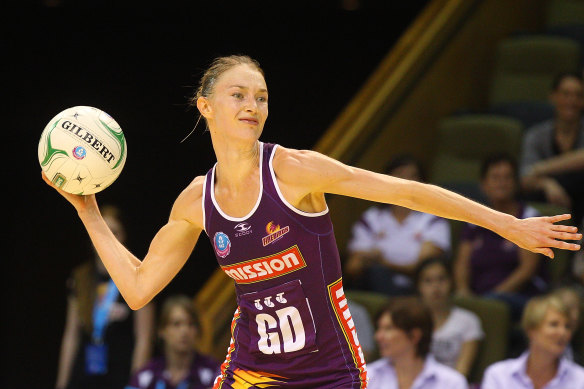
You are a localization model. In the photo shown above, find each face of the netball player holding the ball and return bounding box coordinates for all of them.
[199,64,268,141]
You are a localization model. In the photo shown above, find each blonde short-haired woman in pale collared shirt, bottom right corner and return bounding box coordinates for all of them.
[481,295,584,389]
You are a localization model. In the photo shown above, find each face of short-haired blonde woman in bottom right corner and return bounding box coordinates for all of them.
[528,308,572,357]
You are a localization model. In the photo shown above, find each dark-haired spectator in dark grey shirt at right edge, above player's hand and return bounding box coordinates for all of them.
[521,73,584,224]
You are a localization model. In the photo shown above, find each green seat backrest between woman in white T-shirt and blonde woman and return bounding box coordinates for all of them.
[454,297,511,383]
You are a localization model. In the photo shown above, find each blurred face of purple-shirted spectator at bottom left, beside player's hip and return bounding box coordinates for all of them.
[160,306,197,352]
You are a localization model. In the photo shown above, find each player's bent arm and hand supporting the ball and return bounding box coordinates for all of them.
[43,174,204,310]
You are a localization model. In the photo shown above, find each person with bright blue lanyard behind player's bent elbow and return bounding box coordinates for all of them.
[55,206,154,389]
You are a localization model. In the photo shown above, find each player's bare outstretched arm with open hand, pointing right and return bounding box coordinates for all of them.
[274,148,581,258]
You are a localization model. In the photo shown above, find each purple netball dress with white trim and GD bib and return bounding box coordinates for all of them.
[203,142,367,389]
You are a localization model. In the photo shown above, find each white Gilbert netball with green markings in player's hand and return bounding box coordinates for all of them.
[38,106,128,195]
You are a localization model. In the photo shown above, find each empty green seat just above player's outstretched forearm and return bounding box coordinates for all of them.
[429,114,523,186]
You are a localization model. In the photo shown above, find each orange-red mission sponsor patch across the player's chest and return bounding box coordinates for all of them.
[221,245,306,284]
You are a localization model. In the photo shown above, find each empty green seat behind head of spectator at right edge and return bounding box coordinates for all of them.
[488,34,581,107]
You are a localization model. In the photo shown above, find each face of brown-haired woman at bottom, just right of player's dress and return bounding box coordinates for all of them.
[375,313,416,360]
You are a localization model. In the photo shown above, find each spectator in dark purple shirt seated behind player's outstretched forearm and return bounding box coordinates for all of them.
[455,154,548,321]
